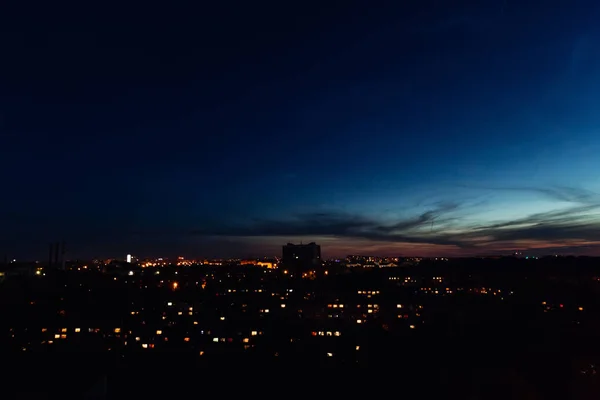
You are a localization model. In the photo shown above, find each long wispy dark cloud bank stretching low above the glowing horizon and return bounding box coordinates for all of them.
[191,187,600,253]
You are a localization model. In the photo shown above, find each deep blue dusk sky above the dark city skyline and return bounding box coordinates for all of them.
[0,0,600,259]
